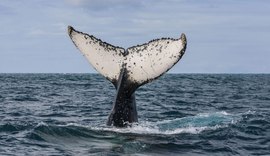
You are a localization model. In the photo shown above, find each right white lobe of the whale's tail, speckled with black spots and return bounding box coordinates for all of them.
[126,34,186,85]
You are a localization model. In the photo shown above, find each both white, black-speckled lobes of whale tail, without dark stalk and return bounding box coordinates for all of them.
[68,26,186,84]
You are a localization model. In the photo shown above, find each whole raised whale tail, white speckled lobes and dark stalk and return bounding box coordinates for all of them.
[68,26,187,127]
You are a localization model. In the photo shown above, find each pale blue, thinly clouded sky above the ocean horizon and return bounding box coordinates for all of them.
[0,0,270,73]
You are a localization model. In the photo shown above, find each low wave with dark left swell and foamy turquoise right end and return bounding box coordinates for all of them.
[26,112,246,140]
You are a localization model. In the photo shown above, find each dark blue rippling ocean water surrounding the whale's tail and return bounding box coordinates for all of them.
[0,74,270,156]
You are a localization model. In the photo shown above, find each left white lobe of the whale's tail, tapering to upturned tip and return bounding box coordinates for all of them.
[68,26,125,86]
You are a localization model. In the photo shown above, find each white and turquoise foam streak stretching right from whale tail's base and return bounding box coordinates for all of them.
[91,111,237,135]
